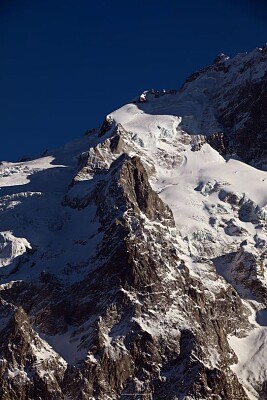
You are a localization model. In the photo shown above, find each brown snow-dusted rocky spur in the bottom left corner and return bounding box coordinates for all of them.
[0,301,67,399]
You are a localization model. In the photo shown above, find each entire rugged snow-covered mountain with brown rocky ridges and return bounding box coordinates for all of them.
[0,46,267,400]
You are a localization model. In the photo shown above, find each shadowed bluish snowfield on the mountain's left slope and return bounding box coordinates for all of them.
[0,137,101,283]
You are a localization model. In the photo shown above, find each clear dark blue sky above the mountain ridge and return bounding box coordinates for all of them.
[0,0,267,161]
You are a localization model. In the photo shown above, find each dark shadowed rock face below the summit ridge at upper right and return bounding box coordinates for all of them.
[183,45,267,169]
